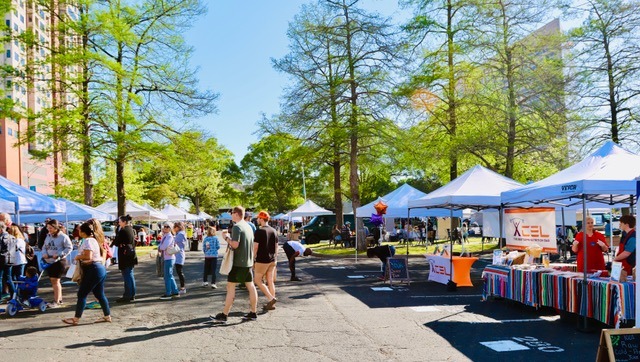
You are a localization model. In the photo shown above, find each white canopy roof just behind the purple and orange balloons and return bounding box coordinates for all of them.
[356,184,461,218]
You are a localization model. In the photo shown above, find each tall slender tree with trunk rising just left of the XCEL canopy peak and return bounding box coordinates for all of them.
[404,0,471,180]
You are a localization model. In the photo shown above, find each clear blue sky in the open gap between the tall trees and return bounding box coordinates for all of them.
[186,0,398,163]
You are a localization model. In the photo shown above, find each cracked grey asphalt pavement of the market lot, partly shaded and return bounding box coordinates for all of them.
[0,245,600,361]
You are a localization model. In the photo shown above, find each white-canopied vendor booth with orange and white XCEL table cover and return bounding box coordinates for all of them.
[409,165,522,289]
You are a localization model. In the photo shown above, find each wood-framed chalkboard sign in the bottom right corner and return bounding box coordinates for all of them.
[596,328,640,362]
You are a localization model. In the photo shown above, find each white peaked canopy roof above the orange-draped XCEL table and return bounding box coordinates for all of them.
[409,165,522,209]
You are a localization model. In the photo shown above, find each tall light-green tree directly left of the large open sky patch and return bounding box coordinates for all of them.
[93,0,217,214]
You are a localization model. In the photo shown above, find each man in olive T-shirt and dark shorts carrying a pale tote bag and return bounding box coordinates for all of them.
[212,206,258,323]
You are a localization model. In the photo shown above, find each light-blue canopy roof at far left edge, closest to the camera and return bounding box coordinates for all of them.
[0,176,67,224]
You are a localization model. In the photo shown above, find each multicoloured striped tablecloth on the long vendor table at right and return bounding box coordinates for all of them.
[482,265,636,328]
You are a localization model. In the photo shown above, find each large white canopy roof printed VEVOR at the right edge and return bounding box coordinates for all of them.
[502,141,640,207]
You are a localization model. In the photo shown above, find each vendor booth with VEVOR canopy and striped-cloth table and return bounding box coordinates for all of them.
[498,142,640,329]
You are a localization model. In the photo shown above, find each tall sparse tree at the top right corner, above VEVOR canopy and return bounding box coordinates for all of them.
[570,0,640,148]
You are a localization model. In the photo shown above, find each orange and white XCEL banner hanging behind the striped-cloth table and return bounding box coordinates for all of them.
[504,207,558,253]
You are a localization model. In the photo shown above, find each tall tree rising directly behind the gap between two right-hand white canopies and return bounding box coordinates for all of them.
[461,0,567,177]
